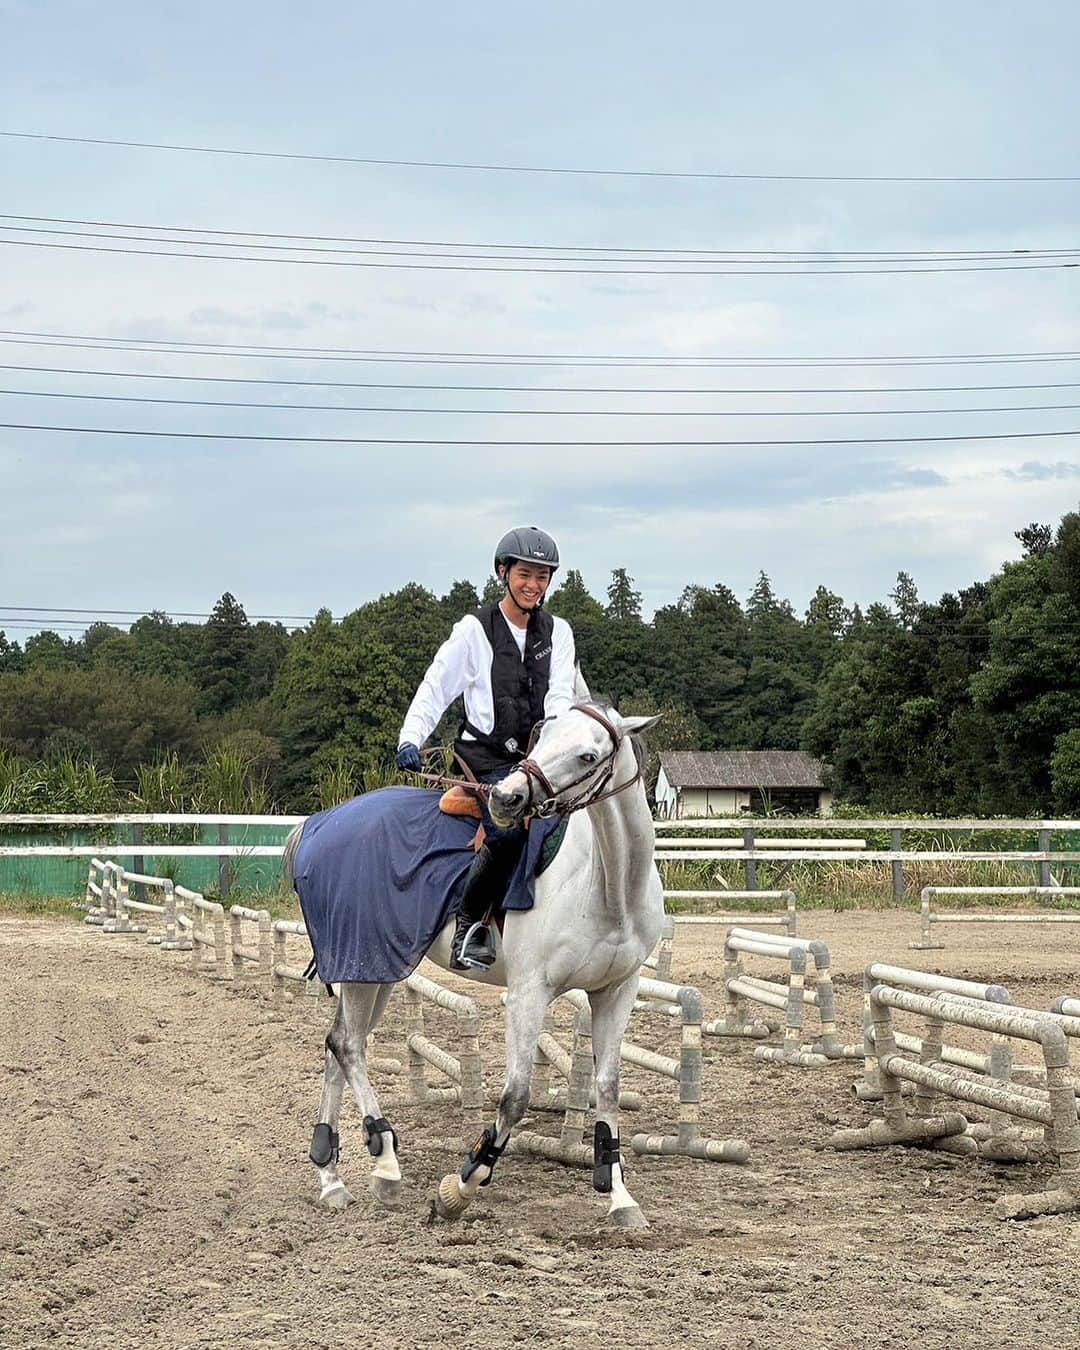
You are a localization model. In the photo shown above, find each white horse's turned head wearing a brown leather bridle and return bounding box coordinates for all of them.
[487,702,659,828]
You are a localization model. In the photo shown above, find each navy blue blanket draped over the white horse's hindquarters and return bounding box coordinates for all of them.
[293,787,562,984]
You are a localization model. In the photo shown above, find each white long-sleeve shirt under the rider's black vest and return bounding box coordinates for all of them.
[397,614,578,745]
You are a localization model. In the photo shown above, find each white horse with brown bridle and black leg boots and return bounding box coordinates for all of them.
[285,702,664,1227]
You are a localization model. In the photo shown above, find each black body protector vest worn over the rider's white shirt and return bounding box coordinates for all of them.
[454,605,555,776]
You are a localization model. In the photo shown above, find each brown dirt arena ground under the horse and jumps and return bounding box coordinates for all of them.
[0,911,1080,1350]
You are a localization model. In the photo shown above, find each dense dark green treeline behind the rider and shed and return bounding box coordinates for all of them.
[8,513,1080,817]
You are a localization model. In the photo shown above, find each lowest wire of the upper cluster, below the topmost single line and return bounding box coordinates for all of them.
[8,236,1080,277]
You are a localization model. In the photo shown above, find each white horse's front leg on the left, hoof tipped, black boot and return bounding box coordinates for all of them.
[435,986,552,1219]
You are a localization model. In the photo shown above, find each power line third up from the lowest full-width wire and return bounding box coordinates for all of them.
[0,361,1080,396]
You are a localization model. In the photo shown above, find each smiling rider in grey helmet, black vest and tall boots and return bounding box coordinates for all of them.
[396,525,575,969]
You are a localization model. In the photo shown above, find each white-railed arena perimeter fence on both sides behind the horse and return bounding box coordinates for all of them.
[0,813,1080,945]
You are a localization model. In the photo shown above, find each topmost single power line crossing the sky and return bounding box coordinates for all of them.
[0,131,1080,184]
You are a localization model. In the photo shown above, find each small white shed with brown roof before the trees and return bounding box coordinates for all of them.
[656,751,833,819]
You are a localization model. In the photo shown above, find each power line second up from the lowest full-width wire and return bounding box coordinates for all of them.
[0,389,1080,417]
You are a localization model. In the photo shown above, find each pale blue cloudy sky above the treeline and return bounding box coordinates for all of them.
[0,0,1080,640]
